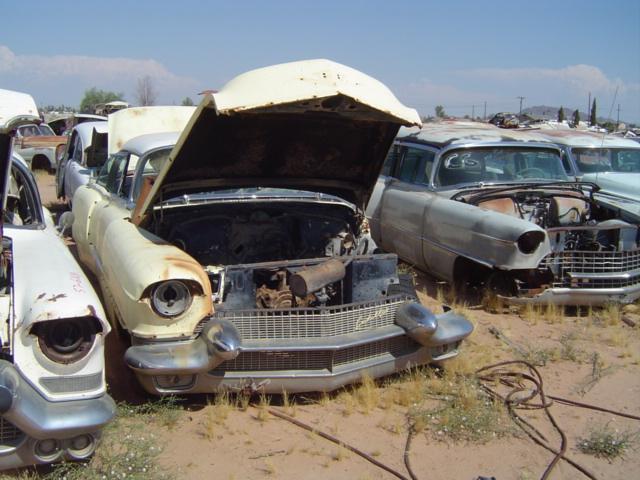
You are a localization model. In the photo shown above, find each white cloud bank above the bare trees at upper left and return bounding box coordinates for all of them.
[0,45,200,103]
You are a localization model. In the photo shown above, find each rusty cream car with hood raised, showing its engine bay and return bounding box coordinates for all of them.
[73,60,472,393]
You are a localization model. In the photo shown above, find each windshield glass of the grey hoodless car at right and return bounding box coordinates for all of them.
[435,147,568,187]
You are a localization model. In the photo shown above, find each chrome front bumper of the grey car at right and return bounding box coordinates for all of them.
[504,284,640,306]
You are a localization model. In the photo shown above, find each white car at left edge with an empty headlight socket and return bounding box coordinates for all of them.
[0,90,115,469]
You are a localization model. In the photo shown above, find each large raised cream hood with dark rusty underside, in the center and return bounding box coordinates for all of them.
[139,60,420,222]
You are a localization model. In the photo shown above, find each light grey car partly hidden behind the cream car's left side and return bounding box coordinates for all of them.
[56,121,107,205]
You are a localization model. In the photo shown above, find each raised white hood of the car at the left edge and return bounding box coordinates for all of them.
[0,89,40,237]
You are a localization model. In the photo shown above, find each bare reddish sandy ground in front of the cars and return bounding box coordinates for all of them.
[38,174,640,480]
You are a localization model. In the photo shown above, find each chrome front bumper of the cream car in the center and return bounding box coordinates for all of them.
[125,299,473,394]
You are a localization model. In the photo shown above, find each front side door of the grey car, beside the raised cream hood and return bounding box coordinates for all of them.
[380,145,435,268]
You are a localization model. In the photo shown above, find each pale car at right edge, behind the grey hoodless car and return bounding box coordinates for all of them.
[540,130,640,202]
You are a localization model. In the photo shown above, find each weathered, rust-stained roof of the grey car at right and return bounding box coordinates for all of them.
[396,120,553,147]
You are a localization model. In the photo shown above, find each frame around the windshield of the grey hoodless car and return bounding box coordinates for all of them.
[430,142,572,191]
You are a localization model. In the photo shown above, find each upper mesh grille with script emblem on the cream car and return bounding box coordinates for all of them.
[194,296,406,340]
